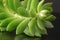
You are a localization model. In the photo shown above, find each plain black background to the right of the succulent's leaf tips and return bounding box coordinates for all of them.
[45,0,60,40]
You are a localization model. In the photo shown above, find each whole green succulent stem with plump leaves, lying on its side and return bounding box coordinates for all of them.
[0,0,56,37]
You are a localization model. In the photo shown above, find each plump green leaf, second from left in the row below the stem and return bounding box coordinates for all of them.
[6,19,23,32]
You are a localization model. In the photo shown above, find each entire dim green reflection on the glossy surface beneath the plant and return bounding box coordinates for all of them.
[0,32,41,40]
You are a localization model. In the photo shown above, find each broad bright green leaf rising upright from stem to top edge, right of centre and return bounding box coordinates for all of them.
[29,0,38,17]
